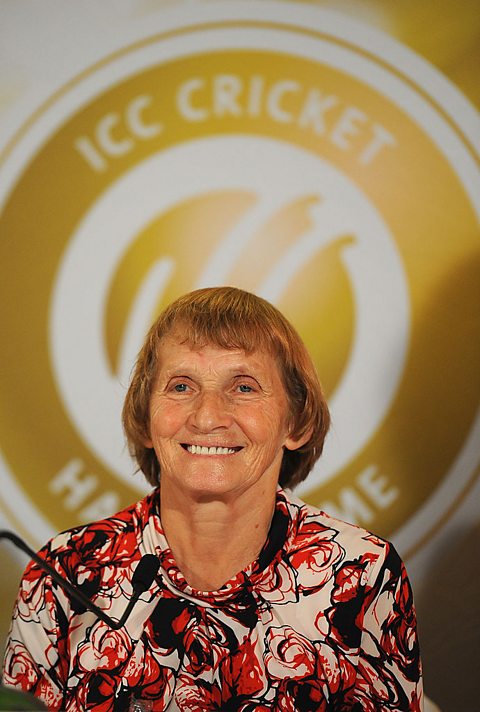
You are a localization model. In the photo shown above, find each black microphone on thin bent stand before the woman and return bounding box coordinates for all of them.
[0,529,160,630]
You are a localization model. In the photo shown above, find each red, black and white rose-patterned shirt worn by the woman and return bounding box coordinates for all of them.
[4,490,422,712]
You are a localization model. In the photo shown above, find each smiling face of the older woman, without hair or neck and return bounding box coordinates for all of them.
[145,337,303,497]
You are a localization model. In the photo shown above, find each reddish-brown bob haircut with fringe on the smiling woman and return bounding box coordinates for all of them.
[122,287,330,487]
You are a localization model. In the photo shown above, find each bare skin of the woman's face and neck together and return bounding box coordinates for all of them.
[141,334,308,590]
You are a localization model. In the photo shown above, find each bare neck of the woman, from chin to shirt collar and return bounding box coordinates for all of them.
[160,485,276,591]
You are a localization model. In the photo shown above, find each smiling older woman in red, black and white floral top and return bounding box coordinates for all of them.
[4,287,422,712]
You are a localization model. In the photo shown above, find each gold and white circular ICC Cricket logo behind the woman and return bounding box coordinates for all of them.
[0,4,480,550]
